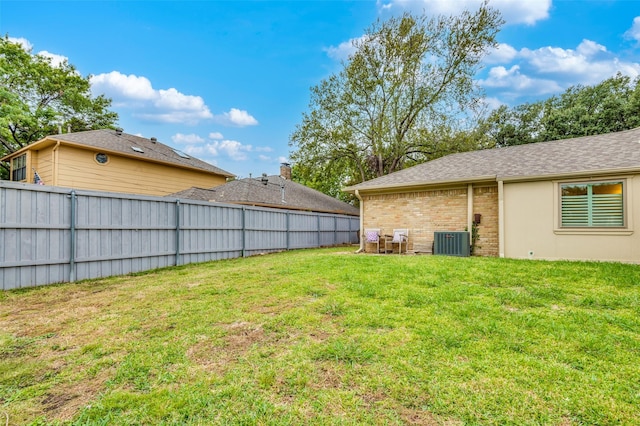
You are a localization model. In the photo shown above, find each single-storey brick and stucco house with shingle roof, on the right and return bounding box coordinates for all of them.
[345,128,640,263]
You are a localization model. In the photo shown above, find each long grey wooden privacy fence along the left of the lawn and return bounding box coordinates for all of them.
[0,181,360,290]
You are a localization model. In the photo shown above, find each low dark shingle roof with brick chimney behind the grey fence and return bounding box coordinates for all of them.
[168,175,360,216]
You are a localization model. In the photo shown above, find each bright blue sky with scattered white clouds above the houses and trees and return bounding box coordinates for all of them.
[0,0,640,177]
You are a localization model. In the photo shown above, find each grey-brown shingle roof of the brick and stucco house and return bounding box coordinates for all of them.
[344,127,640,192]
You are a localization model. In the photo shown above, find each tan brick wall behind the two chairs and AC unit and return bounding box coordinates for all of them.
[362,186,498,256]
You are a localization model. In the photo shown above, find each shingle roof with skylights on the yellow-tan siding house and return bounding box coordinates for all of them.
[2,129,234,177]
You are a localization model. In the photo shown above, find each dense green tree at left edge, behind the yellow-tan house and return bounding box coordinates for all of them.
[0,37,118,179]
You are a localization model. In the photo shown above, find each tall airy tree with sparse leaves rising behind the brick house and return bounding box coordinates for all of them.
[290,3,502,190]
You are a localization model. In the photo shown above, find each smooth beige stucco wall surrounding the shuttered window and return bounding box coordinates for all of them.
[504,176,640,263]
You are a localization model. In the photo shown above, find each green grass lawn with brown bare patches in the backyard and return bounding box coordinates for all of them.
[0,248,640,425]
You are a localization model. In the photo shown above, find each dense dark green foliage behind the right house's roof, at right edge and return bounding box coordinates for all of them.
[481,74,640,146]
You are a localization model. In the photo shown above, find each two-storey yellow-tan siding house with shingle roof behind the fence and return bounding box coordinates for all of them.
[2,130,233,195]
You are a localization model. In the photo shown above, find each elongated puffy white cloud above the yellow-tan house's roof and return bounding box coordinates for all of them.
[91,71,213,124]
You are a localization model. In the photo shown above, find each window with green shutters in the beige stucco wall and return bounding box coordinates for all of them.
[560,181,624,228]
